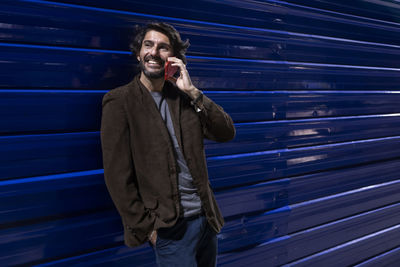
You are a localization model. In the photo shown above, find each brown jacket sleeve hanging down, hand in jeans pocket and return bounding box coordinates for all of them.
[101,90,155,245]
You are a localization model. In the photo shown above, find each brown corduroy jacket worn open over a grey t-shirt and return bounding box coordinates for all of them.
[101,75,235,247]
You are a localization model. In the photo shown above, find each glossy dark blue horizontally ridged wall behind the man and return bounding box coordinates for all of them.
[0,0,400,266]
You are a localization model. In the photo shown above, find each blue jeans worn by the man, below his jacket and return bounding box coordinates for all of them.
[153,215,218,267]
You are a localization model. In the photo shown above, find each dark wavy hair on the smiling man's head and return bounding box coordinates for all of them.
[129,22,190,64]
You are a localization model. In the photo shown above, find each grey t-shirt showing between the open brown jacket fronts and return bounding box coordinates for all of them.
[150,92,201,217]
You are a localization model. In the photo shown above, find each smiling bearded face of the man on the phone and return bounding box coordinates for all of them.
[137,30,173,79]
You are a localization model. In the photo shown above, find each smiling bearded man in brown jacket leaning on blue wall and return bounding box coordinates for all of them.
[101,23,235,266]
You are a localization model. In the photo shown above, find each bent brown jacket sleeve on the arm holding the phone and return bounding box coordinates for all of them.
[197,95,236,142]
